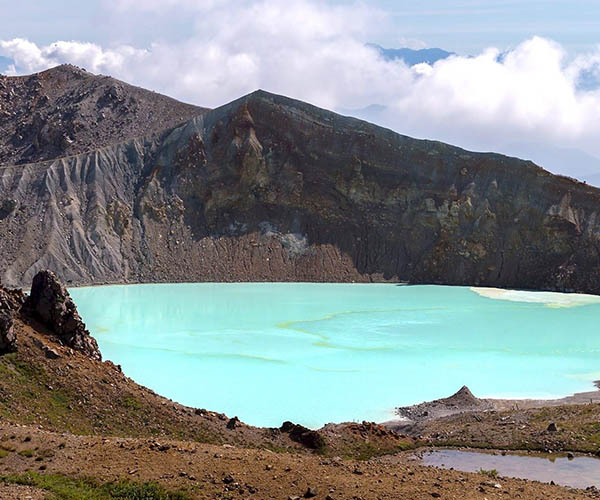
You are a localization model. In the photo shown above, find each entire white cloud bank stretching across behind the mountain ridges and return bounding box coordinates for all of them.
[0,0,600,180]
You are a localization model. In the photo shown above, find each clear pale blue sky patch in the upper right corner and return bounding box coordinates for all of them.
[368,0,600,54]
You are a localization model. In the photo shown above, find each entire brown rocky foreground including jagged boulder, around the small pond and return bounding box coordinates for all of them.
[0,271,600,500]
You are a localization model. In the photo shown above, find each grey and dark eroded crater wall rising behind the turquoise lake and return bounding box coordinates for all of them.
[0,72,600,293]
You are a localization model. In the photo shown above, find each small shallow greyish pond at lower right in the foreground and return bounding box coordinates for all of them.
[422,450,600,488]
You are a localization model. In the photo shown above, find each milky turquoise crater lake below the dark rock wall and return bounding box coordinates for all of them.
[70,283,600,427]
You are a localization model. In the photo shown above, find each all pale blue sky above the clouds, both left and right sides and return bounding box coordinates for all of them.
[0,0,600,54]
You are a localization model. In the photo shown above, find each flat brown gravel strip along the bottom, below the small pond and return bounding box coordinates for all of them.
[0,425,594,500]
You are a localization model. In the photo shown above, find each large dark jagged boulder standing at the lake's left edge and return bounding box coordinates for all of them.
[23,271,102,361]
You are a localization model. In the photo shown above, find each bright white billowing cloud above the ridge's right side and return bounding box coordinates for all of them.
[382,37,600,158]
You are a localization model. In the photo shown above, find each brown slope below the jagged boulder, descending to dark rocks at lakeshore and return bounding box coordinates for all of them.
[0,312,292,447]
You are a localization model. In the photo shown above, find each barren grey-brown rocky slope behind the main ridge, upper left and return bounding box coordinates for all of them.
[0,65,206,165]
